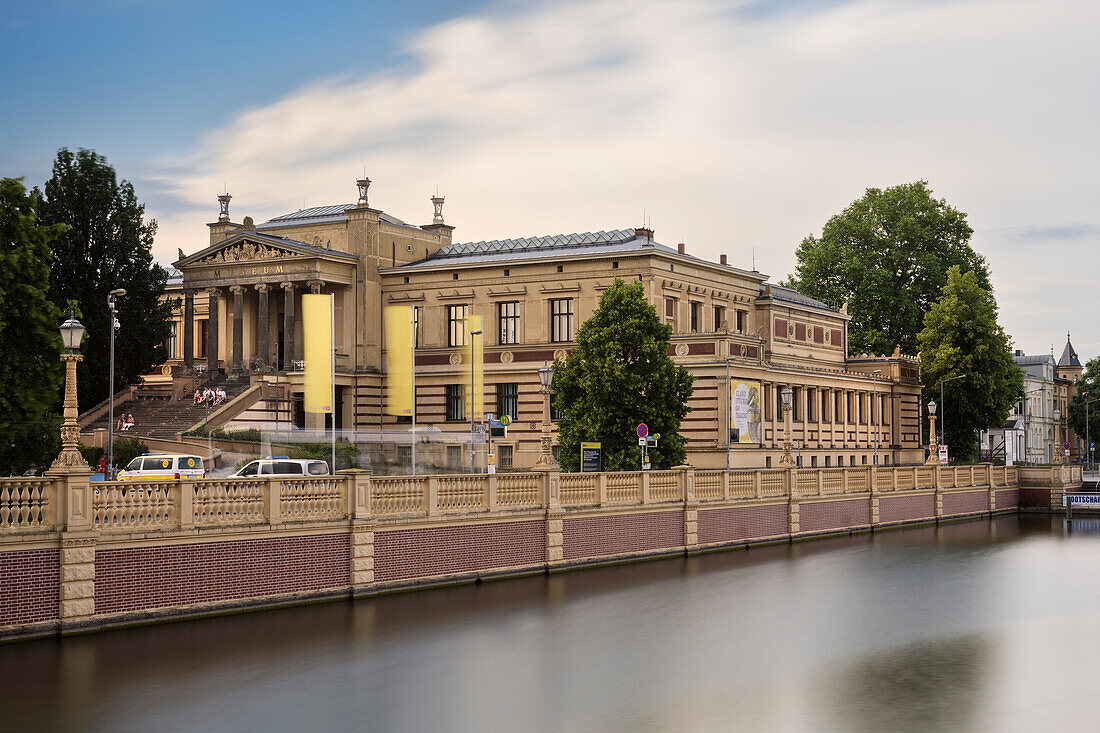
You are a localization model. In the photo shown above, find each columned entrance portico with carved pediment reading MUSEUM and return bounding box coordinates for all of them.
[175,225,359,374]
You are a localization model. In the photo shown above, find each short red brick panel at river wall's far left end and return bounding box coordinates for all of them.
[0,549,61,626]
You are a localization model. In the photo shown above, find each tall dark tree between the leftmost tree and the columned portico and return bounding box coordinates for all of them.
[41,149,173,409]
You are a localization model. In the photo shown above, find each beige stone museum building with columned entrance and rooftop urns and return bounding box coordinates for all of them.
[166,178,924,470]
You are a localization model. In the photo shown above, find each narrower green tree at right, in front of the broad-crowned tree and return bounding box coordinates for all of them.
[917,265,1024,462]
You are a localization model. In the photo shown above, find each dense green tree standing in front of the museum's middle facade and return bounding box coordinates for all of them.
[553,278,694,471]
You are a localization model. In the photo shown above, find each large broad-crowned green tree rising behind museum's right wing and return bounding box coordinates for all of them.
[785,180,990,354]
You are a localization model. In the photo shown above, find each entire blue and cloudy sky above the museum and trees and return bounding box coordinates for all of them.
[0,0,1100,360]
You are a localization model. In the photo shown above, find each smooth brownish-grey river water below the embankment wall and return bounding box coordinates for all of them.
[0,516,1100,732]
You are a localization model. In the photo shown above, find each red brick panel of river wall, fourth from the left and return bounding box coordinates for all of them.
[562,511,684,560]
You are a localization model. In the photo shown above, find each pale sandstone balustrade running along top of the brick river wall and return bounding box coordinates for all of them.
[0,464,1038,534]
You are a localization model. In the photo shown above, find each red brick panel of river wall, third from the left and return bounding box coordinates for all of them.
[374,519,547,581]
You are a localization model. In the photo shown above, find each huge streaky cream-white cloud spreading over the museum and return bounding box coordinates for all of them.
[151,0,1100,354]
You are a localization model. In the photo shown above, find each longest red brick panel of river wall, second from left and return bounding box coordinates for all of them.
[96,533,351,613]
